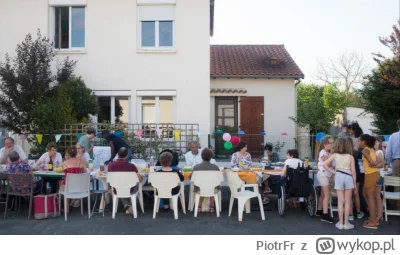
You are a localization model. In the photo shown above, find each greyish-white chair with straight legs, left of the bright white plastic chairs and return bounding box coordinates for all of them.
[58,173,90,221]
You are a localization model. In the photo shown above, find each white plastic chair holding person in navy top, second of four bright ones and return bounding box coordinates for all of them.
[149,172,186,220]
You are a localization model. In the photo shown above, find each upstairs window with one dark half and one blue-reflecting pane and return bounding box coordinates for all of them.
[52,6,86,49]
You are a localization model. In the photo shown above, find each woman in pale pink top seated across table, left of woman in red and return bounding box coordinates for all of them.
[36,142,62,194]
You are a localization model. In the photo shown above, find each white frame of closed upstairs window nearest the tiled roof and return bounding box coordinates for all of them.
[138,20,176,52]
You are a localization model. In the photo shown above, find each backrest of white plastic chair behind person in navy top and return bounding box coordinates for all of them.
[149,172,181,198]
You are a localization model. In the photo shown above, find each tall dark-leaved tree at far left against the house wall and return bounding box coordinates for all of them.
[0,30,75,134]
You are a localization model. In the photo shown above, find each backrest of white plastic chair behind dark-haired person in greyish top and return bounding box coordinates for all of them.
[191,170,224,196]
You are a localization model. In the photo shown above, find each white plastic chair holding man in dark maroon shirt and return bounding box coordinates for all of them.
[107,172,144,219]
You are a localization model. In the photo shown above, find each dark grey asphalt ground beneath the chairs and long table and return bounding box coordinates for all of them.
[0,187,400,235]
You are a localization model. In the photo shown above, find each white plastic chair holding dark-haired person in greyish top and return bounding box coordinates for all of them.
[191,170,224,217]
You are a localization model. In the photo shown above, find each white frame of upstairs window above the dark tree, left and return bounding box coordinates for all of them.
[49,5,87,53]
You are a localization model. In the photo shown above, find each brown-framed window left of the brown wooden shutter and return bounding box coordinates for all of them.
[215,97,238,127]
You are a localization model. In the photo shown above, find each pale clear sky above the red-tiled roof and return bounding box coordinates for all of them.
[211,0,400,82]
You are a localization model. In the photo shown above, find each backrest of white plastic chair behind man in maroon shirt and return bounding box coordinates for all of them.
[107,172,139,197]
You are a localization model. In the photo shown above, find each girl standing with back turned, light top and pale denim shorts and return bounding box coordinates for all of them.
[323,138,357,230]
